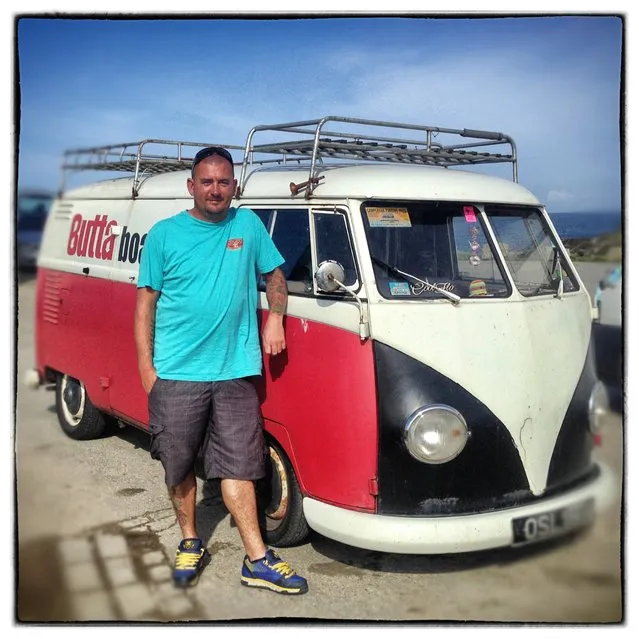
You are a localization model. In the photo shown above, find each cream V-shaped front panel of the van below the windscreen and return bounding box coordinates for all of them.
[369,293,590,495]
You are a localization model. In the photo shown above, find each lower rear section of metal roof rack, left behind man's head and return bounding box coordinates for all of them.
[60,139,244,198]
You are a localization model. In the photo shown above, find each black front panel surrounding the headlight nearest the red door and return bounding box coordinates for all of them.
[374,342,533,515]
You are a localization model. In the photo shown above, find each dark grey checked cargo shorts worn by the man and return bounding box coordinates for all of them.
[148,377,266,487]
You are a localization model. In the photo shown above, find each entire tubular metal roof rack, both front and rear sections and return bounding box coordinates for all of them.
[60,116,518,198]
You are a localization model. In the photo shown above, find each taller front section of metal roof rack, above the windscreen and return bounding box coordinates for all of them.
[237,116,518,198]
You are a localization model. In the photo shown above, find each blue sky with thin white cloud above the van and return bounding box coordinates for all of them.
[14,14,623,212]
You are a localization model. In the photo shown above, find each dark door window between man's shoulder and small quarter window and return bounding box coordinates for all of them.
[271,209,313,293]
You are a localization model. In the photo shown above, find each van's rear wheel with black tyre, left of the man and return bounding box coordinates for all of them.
[55,374,107,439]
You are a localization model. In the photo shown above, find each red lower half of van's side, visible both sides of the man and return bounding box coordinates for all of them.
[36,269,377,512]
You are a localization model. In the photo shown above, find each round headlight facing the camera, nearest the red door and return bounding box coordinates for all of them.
[404,404,469,464]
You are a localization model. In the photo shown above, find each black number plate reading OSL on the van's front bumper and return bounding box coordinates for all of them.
[513,499,595,546]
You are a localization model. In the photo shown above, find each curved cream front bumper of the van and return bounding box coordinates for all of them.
[303,464,618,554]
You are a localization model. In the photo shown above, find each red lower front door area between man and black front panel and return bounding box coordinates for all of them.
[259,311,378,512]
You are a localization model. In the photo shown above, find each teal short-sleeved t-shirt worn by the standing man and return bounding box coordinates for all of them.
[138,208,284,382]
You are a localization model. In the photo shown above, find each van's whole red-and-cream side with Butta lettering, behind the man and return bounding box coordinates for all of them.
[37,188,378,512]
